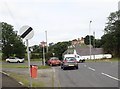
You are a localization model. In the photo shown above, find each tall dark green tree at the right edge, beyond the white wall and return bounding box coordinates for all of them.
[101,11,120,57]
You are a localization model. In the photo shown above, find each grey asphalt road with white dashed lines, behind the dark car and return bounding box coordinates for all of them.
[54,62,120,89]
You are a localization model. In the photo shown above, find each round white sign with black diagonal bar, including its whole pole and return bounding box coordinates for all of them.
[20,25,34,87]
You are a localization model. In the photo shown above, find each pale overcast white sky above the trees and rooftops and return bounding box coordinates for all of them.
[0,0,119,46]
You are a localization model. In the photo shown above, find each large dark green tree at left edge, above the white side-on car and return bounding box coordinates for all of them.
[0,22,25,59]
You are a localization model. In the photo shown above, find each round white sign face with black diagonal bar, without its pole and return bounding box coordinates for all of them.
[20,25,34,40]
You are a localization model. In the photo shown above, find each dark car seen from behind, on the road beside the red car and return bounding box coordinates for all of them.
[61,57,78,70]
